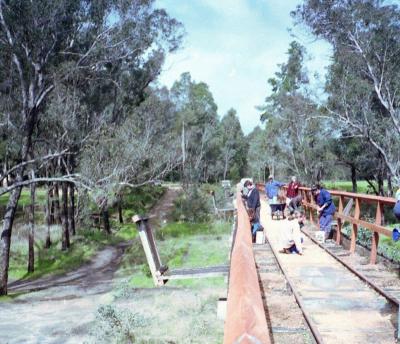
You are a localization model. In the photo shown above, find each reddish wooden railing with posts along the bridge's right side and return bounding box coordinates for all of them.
[257,183,396,264]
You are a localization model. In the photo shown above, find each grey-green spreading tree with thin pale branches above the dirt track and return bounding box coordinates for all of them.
[78,89,181,233]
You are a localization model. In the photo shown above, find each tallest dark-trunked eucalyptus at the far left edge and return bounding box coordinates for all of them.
[0,0,181,295]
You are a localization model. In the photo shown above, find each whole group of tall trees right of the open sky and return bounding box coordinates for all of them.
[252,0,400,194]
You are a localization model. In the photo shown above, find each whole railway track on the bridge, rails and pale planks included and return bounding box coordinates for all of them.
[254,200,400,344]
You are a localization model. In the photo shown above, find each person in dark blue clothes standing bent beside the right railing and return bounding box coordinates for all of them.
[311,184,336,239]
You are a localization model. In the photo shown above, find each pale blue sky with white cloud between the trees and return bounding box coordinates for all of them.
[156,0,330,134]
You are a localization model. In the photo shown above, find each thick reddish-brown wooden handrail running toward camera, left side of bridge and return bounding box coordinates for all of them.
[224,191,271,344]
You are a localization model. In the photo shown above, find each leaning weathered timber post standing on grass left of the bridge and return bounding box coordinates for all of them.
[132,215,166,286]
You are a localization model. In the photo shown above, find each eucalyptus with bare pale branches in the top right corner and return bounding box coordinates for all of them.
[294,0,400,183]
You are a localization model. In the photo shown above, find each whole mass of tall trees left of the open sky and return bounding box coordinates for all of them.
[0,0,250,295]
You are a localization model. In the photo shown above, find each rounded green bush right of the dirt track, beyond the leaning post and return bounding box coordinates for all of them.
[172,187,210,223]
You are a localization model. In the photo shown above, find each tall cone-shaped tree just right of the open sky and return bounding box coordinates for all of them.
[260,41,327,182]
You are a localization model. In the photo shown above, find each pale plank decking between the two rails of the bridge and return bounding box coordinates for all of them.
[261,201,395,344]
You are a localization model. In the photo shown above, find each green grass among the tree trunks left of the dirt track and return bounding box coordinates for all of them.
[6,186,166,281]
